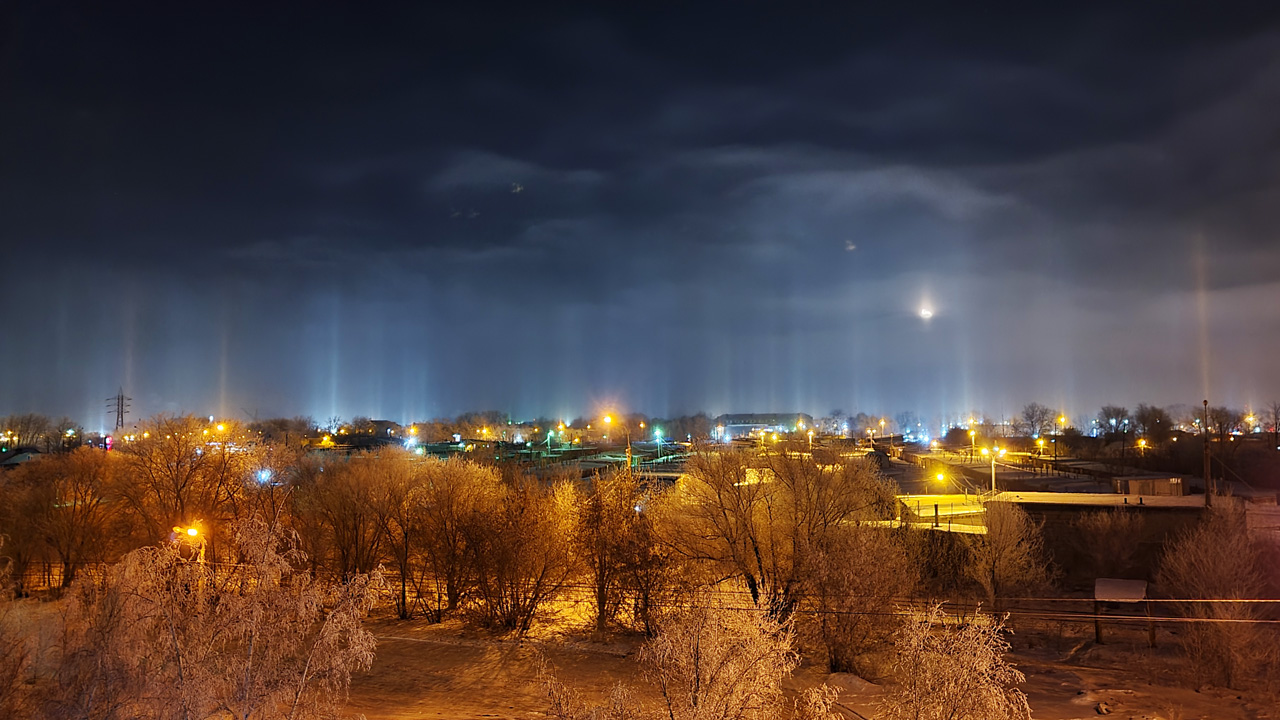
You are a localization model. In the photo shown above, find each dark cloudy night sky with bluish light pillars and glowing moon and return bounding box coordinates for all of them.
[0,3,1280,429]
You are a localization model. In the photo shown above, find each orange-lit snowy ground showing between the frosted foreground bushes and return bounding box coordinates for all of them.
[348,620,1280,720]
